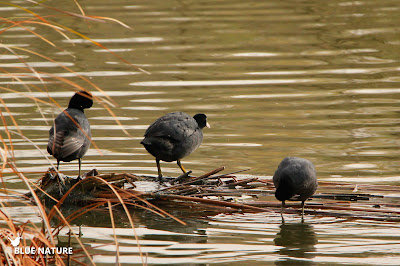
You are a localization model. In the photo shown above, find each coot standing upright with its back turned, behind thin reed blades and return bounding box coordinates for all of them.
[47,91,93,176]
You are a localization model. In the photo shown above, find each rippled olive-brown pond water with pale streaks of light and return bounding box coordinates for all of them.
[0,0,400,265]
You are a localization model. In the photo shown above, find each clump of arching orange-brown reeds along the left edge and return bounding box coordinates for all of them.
[0,0,155,265]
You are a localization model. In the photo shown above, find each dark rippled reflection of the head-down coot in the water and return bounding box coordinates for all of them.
[274,223,318,265]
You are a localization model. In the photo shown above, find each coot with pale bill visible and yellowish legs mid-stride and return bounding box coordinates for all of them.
[140,112,210,181]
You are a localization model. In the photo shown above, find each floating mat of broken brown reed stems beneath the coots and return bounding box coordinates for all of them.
[32,167,400,221]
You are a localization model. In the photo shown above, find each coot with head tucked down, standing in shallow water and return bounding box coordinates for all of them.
[273,157,318,219]
